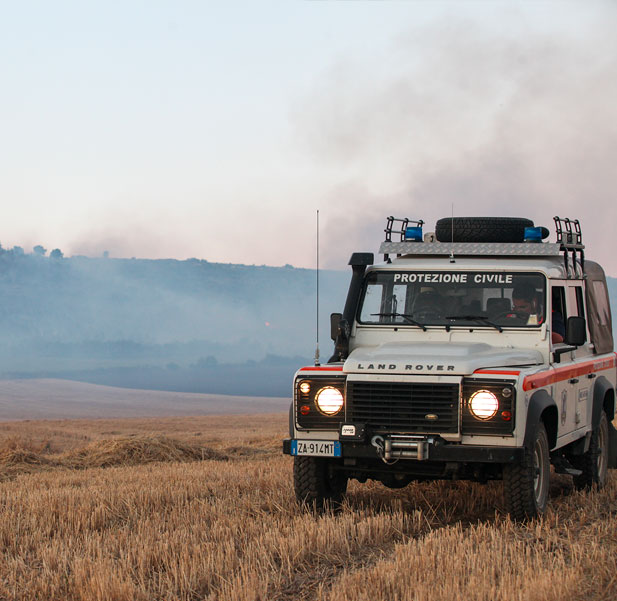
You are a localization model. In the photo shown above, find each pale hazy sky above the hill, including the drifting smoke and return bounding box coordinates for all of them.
[0,0,617,275]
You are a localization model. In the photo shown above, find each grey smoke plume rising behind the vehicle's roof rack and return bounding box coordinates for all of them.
[296,3,617,275]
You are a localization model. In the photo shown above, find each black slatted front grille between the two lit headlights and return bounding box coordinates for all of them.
[347,382,460,434]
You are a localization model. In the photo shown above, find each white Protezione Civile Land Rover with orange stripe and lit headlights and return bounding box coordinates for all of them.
[283,217,617,519]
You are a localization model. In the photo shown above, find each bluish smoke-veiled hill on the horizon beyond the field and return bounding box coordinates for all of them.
[0,248,617,396]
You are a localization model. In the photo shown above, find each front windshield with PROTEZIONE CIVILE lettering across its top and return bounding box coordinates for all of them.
[358,271,546,331]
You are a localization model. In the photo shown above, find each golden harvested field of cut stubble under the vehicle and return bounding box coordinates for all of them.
[0,415,617,601]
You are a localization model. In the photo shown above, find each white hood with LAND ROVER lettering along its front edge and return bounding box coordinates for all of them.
[343,342,543,375]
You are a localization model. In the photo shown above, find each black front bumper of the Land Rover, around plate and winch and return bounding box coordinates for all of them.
[283,437,525,463]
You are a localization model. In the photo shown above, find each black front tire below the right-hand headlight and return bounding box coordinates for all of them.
[503,423,551,520]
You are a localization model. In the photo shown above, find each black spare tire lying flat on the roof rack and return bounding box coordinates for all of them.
[435,217,536,242]
